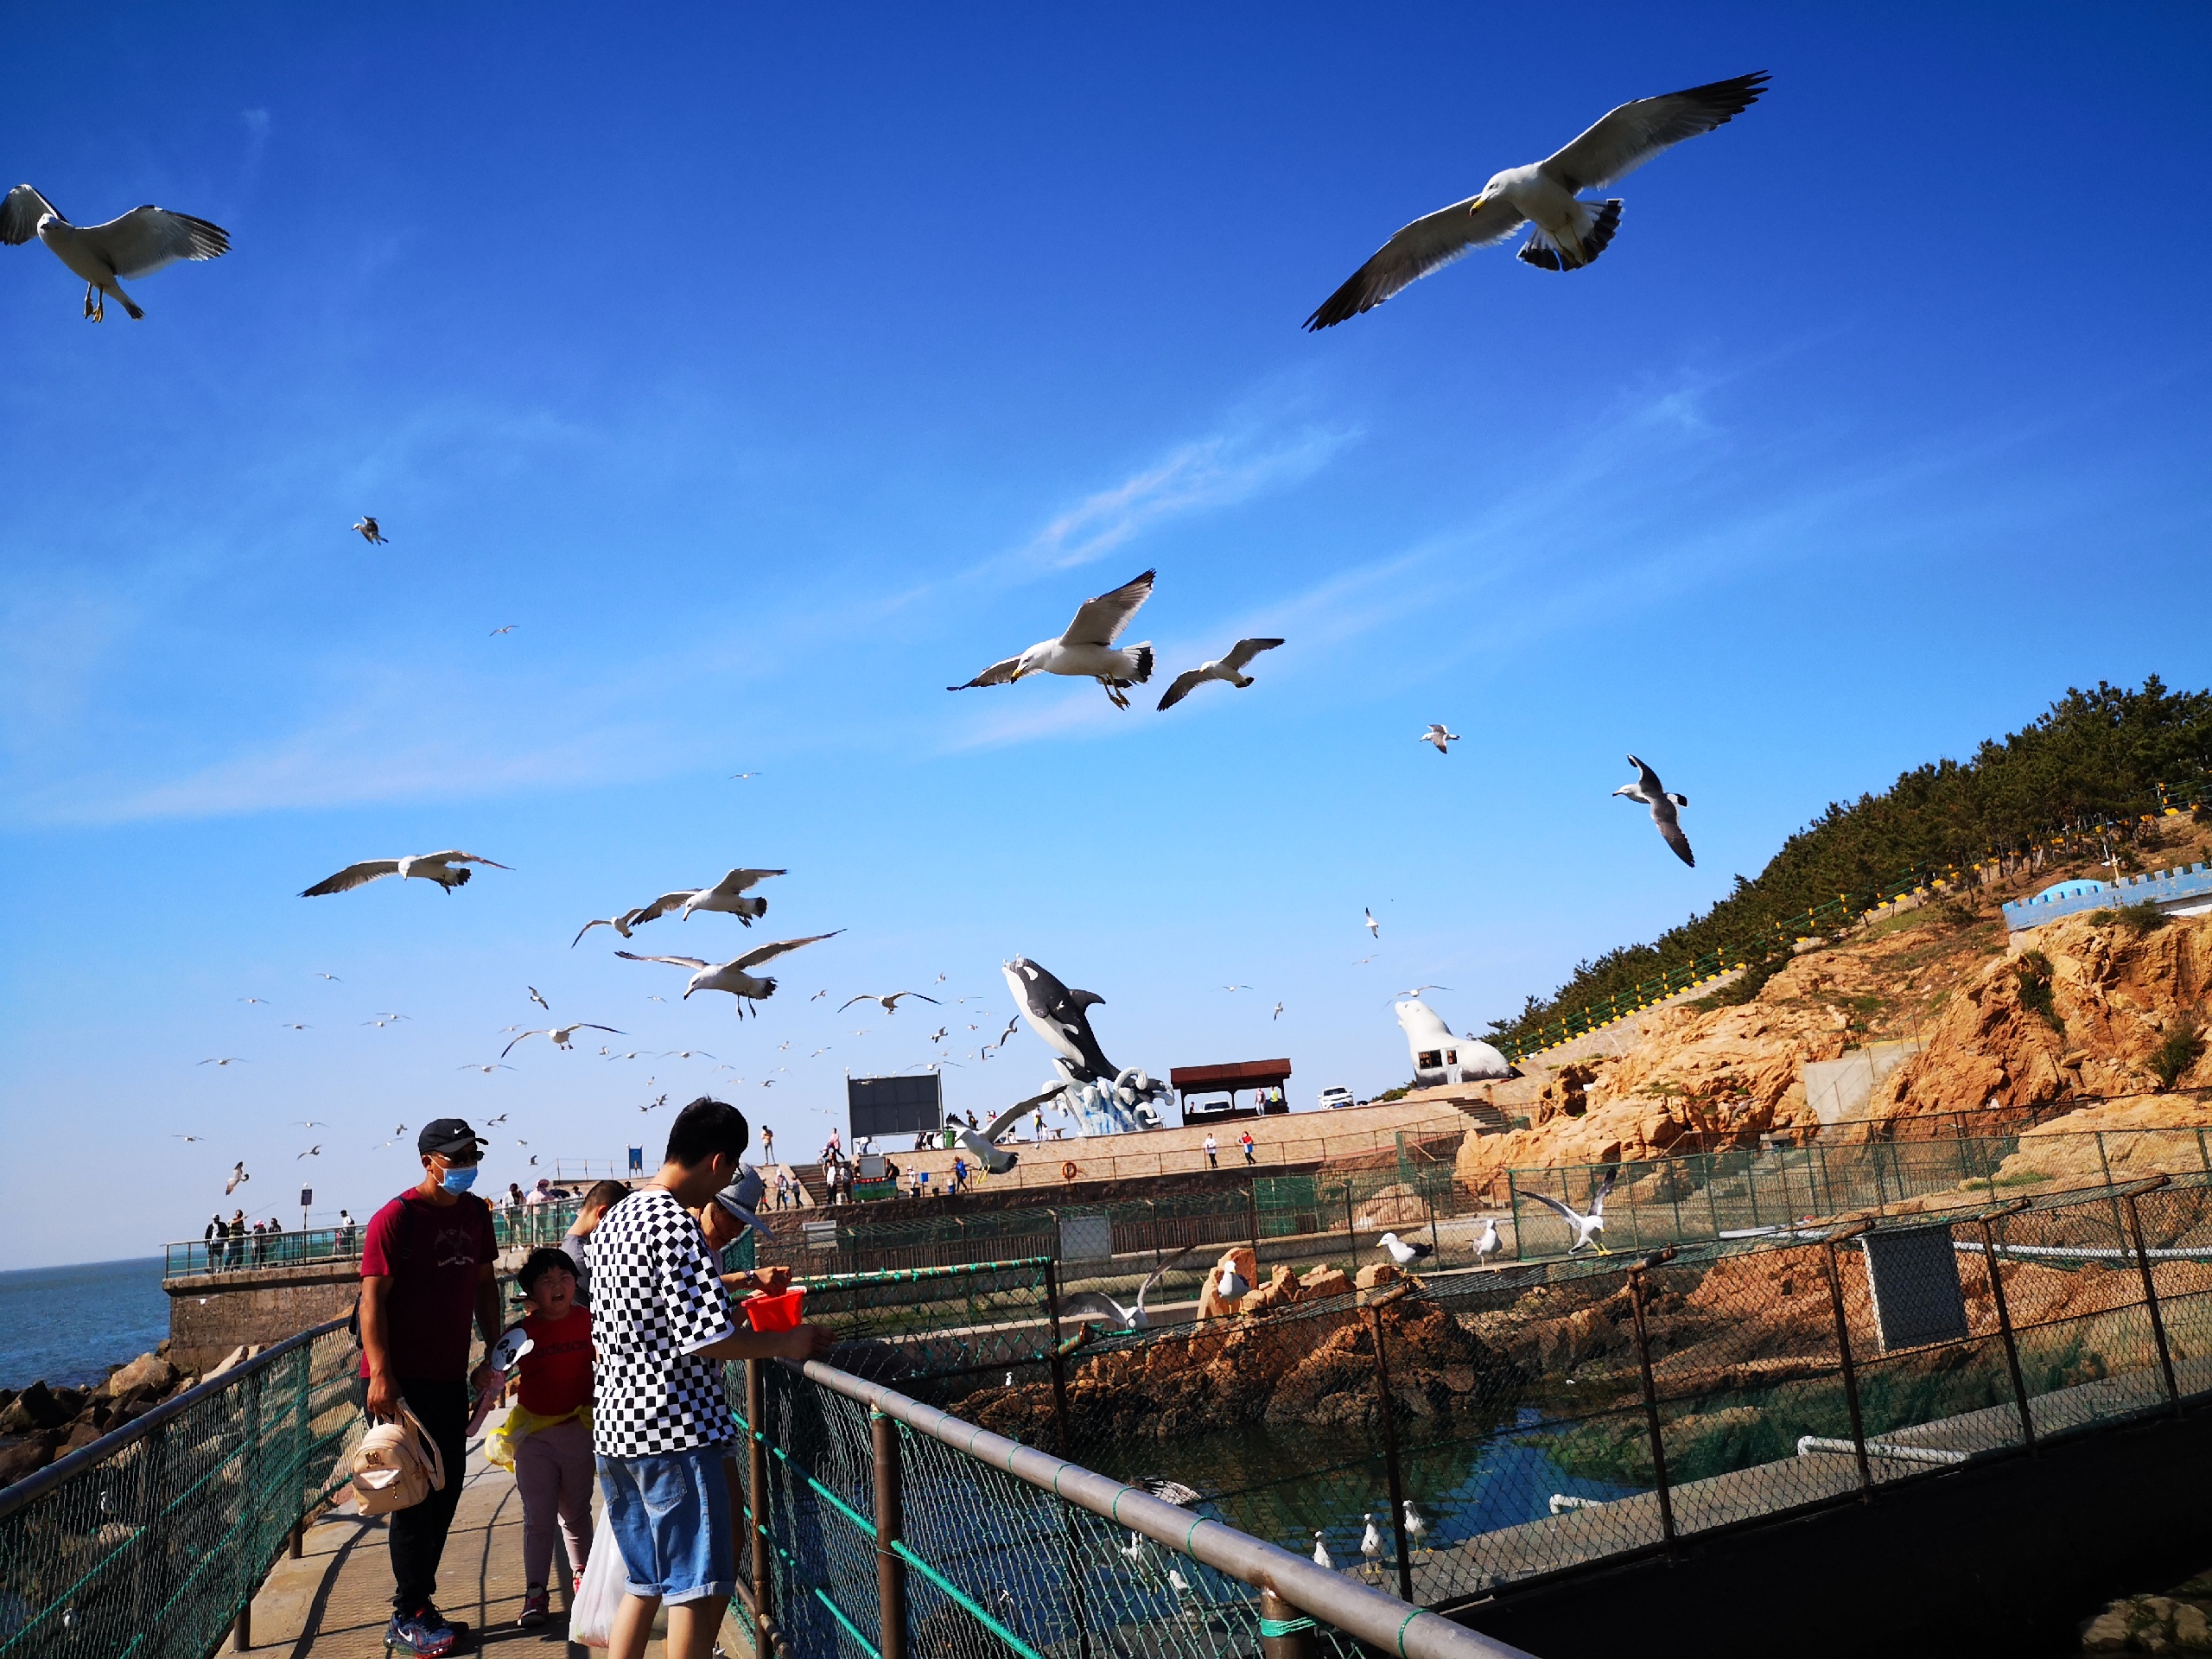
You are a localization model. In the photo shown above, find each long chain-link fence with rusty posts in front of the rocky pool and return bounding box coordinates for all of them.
[867,1174,2212,1606]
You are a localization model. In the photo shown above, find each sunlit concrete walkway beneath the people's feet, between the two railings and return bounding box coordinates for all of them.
[224,1449,750,1659]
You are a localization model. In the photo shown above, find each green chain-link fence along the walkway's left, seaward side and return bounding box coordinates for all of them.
[0,1320,360,1659]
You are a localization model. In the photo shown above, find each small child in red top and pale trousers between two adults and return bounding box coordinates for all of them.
[493,1249,597,1626]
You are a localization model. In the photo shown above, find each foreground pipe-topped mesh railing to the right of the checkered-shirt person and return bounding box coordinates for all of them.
[730,1360,1522,1659]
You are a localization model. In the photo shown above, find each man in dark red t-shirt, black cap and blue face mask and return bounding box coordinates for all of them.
[360,1117,500,1659]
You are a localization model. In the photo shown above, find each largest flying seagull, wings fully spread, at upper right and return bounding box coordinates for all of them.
[1305,73,1767,329]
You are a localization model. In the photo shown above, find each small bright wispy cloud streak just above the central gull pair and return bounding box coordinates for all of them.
[1022,427,1351,570]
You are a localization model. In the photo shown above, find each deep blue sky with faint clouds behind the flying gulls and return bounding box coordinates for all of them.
[0,7,2212,1265]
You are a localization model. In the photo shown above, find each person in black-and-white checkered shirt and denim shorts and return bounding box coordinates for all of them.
[588,1099,832,1659]
